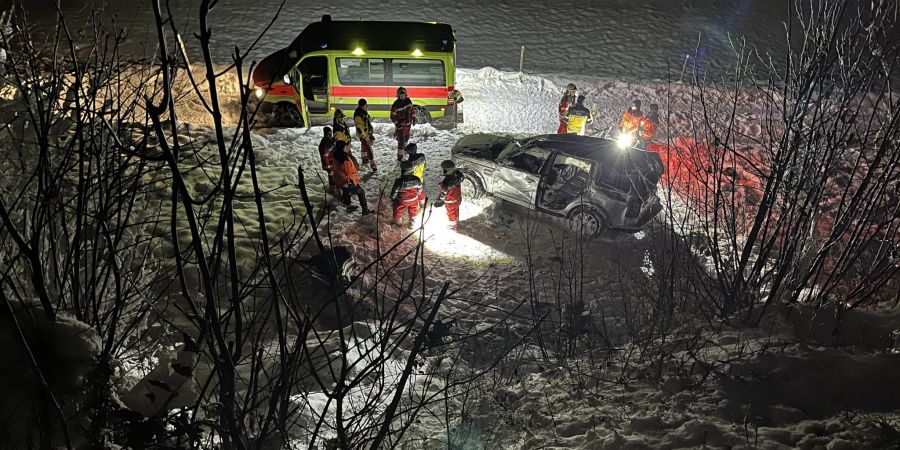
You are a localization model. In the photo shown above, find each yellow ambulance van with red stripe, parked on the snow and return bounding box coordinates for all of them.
[252,15,461,127]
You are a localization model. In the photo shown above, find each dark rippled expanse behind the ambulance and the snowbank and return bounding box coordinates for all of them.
[0,0,788,80]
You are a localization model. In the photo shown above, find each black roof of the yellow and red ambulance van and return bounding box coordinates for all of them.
[289,19,455,55]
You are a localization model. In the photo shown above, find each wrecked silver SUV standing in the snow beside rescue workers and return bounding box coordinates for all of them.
[451,134,663,236]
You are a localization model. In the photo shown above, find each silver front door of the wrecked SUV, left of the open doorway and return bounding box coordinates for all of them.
[491,145,550,209]
